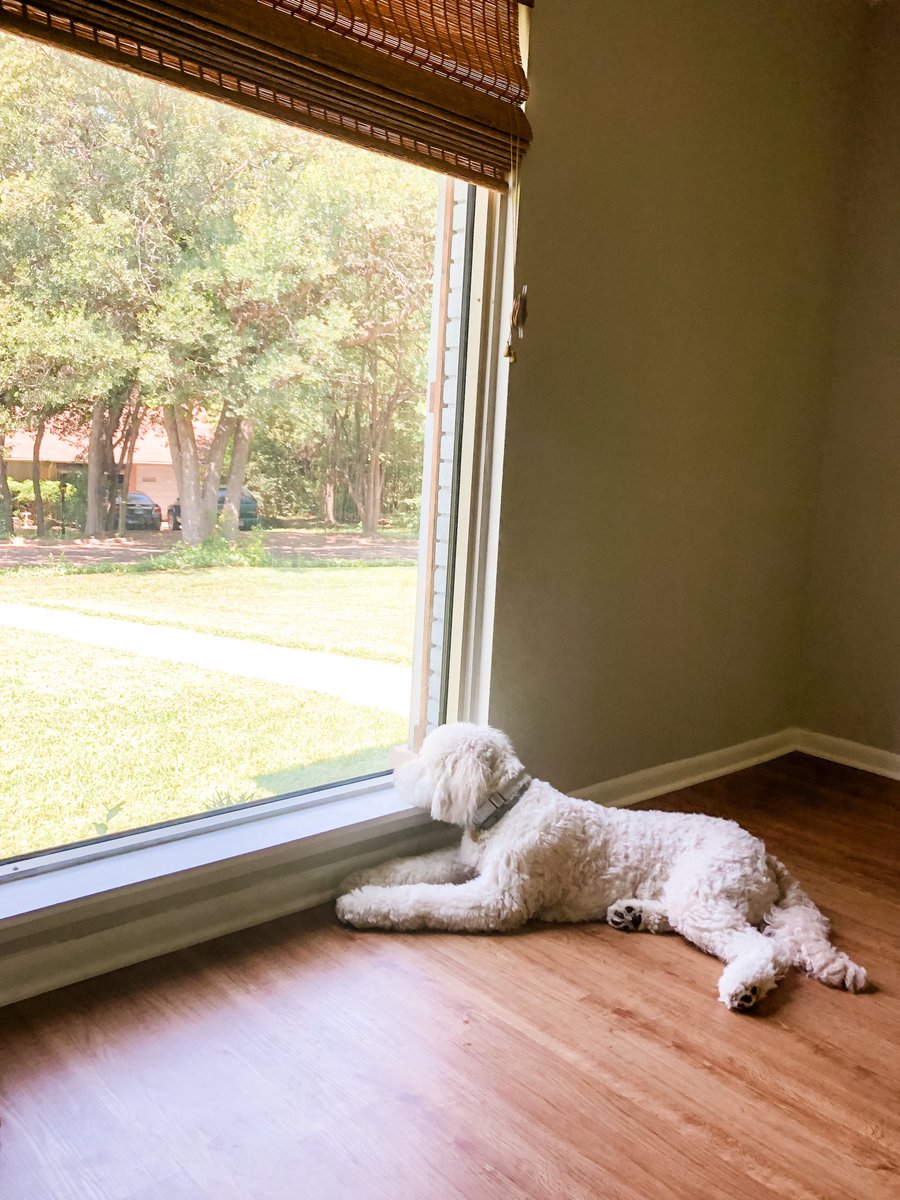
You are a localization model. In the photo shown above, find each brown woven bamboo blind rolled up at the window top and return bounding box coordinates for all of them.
[0,0,530,188]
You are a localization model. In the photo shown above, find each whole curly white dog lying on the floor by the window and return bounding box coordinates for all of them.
[337,724,866,1009]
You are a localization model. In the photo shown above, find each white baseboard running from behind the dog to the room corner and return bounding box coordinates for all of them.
[575,730,799,808]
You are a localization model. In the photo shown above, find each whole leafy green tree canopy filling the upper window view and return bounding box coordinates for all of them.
[0,36,437,541]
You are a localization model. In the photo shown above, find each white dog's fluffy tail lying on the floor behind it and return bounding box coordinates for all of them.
[763,854,868,991]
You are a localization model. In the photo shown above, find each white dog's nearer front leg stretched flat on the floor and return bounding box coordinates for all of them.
[337,877,530,932]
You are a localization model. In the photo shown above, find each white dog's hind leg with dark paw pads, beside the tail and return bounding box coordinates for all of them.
[670,898,788,1009]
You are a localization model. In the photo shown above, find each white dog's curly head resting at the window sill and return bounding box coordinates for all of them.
[394,721,522,826]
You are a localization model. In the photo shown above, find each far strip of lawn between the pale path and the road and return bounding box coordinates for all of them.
[0,563,416,664]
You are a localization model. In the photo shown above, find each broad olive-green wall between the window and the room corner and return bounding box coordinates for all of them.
[490,0,868,788]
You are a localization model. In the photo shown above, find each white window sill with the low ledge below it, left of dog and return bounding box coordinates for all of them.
[0,778,450,1004]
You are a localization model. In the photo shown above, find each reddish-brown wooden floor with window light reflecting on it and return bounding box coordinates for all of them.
[0,755,900,1200]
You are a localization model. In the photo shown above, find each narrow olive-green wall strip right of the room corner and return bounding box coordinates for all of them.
[804,2,900,754]
